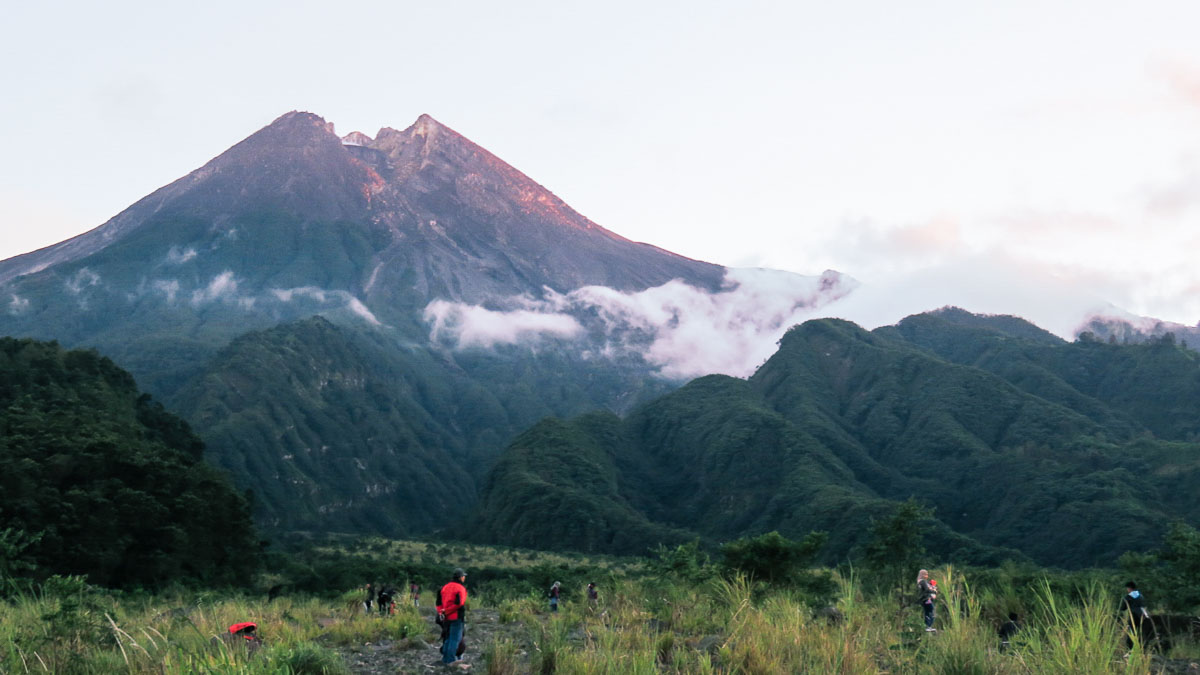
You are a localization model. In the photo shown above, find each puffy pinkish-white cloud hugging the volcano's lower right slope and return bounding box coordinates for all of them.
[425,269,857,378]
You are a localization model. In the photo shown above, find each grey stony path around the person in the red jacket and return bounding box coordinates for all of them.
[337,609,529,675]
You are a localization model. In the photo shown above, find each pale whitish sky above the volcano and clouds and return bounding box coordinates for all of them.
[0,0,1200,324]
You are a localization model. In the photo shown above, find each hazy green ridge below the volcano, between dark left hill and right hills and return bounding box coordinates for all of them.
[170,317,668,536]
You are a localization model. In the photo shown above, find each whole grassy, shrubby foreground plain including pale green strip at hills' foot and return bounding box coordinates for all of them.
[0,534,1200,675]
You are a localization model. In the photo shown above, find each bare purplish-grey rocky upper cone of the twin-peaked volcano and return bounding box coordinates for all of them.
[0,110,724,296]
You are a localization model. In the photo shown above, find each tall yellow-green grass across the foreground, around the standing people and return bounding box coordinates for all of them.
[0,567,1176,675]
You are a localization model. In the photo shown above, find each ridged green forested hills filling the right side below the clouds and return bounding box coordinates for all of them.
[472,311,1200,567]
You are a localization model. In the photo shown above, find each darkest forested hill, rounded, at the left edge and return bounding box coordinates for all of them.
[0,338,258,586]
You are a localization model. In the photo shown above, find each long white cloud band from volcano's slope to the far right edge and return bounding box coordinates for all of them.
[425,256,1190,380]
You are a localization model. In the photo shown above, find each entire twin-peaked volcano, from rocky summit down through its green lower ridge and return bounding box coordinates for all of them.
[0,112,840,536]
